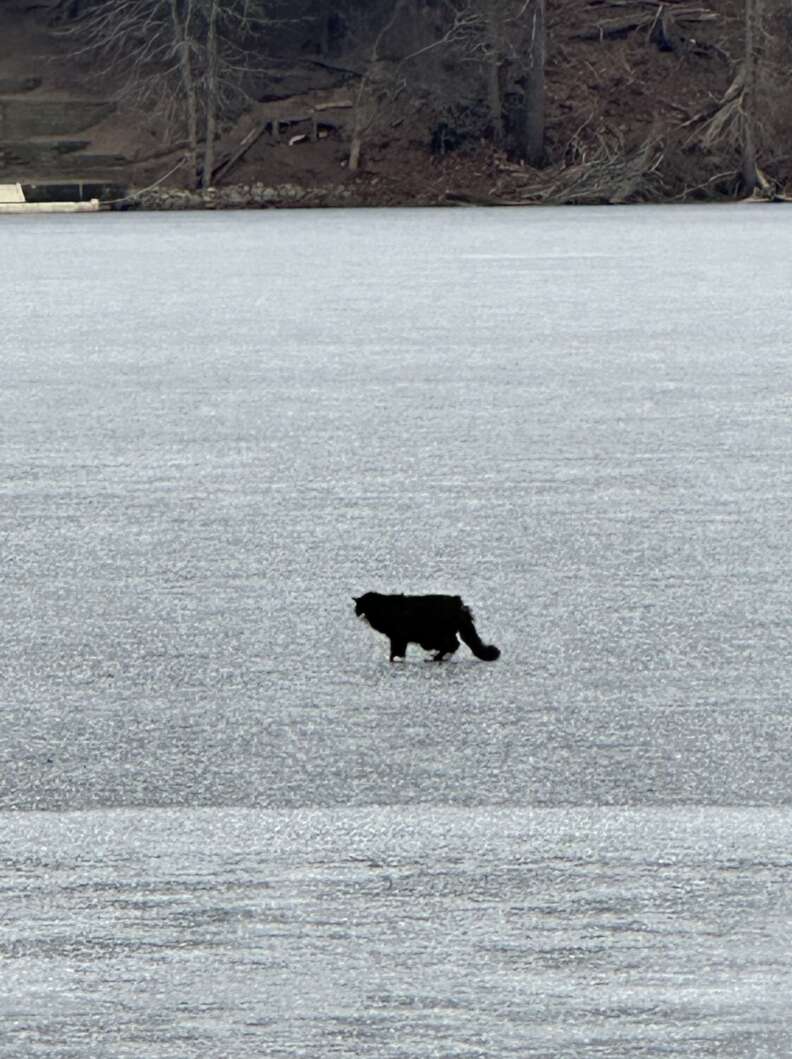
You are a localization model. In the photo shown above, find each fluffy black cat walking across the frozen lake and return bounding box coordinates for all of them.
[355,592,501,662]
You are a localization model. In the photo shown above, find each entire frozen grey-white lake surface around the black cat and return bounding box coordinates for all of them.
[0,207,792,1059]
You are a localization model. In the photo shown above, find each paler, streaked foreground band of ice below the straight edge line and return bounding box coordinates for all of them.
[0,807,792,1059]
